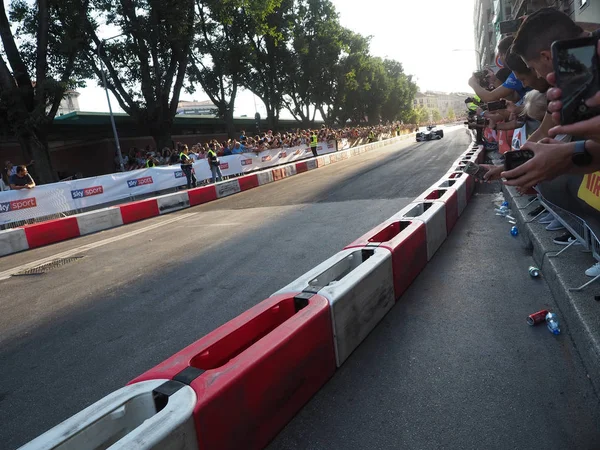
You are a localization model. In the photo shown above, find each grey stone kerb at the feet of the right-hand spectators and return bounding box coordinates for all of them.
[502,185,600,391]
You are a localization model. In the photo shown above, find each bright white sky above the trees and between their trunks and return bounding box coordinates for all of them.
[79,0,476,118]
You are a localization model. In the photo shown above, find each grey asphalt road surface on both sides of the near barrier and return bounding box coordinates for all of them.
[0,129,598,449]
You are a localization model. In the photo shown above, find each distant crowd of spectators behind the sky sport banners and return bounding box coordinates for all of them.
[115,123,415,171]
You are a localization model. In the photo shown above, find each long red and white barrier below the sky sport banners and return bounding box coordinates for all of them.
[0,133,414,257]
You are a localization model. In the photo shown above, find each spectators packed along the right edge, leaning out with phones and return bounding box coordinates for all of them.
[465,8,600,277]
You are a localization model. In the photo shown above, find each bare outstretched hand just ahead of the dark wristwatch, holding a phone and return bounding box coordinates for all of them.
[502,138,575,190]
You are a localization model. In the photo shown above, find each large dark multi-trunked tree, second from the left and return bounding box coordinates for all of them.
[85,0,194,148]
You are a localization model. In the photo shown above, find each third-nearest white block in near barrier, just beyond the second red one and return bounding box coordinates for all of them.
[392,201,448,261]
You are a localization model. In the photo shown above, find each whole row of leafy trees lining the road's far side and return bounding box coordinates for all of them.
[0,0,424,182]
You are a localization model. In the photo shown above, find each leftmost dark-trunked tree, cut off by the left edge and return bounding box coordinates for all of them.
[0,0,88,183]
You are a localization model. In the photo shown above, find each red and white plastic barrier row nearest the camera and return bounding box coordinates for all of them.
[15,132,483,450]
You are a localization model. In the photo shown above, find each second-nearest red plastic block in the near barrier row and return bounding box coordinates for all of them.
[344,219,427,301]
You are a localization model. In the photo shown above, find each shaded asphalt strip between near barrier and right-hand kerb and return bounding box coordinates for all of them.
[269,181,600,450]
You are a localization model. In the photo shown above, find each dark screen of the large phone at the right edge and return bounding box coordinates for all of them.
[557,45,598,124]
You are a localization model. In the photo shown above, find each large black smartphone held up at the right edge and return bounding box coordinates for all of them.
[552,37,600,125]
